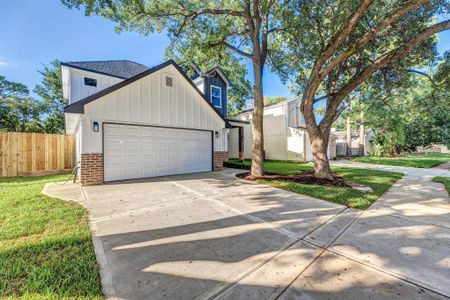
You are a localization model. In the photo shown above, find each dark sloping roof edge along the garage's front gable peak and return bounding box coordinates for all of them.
[64,60,232,128]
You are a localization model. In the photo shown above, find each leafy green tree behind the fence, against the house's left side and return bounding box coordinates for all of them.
[33,60,68,133]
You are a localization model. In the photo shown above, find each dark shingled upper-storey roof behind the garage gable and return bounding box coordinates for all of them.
[61,60,150,79]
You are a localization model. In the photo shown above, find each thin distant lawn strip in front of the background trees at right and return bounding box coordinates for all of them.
[352,153,450,168]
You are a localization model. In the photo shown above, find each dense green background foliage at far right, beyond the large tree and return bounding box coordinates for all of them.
[357,54,450,155]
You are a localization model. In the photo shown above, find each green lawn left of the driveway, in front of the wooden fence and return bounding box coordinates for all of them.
[0,175,103,299]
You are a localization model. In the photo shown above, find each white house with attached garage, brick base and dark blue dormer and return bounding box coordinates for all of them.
[61,61,231,184]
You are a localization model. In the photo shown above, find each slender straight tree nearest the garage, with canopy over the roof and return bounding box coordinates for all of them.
[62,0,281,176]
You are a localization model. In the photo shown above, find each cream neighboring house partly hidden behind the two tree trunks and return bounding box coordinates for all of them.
[228,98,336,161]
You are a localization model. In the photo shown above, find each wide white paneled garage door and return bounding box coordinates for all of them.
[104,124,212,181]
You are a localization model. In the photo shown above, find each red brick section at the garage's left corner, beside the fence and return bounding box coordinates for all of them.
[80,153,103,185]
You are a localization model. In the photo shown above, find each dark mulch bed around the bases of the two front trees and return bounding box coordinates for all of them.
[236,172,373,192]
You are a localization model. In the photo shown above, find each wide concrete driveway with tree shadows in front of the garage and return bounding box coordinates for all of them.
[44,169,450,299]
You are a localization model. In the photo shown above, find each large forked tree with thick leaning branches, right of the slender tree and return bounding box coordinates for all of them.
[273,0,450,179]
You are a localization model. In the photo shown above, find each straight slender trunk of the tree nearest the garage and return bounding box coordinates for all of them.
[250,63,264,176]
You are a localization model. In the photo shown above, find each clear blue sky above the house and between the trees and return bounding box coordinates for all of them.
[0,0,450,98]
